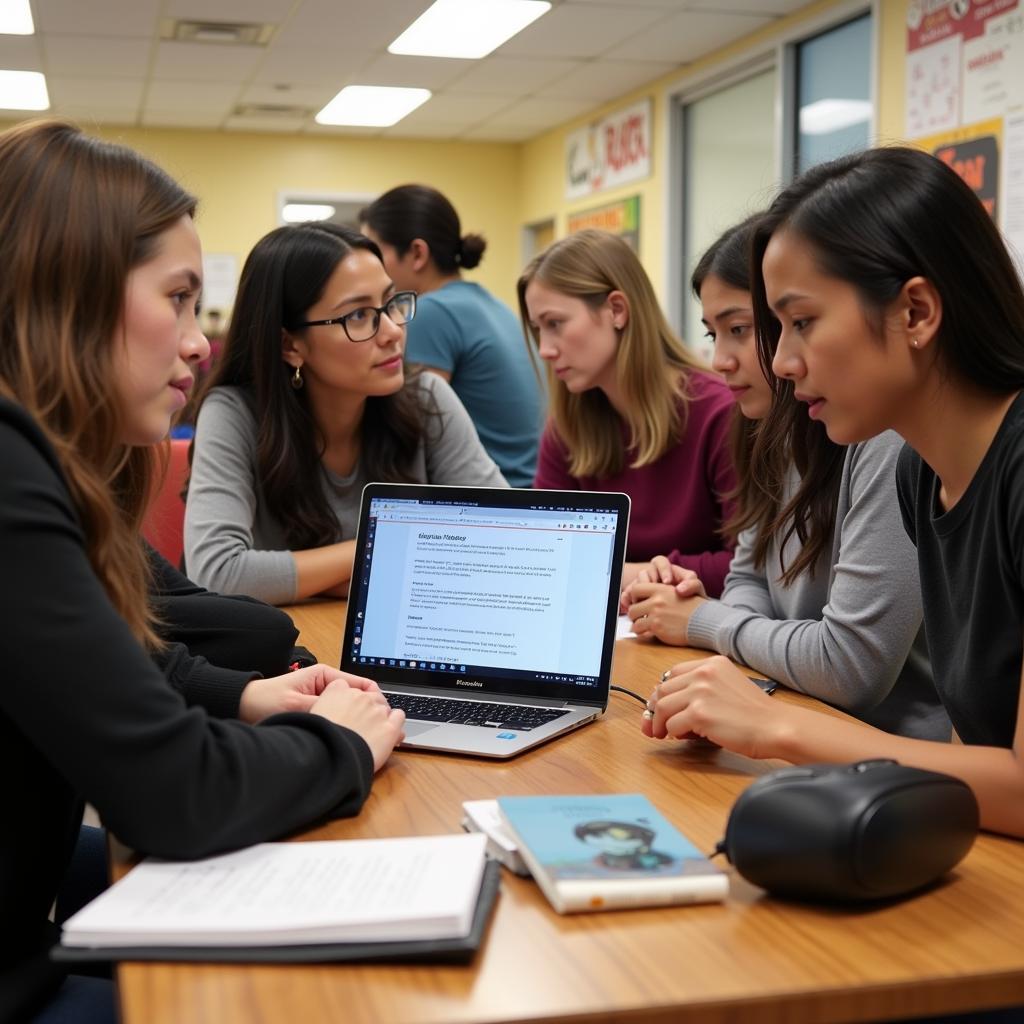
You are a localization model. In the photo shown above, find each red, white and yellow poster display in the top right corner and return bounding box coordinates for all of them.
[906,0,1024,274]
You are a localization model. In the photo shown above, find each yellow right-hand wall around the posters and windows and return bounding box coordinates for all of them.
[520,0,906,301]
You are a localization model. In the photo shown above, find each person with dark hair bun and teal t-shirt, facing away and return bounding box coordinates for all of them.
[359,184,545,487]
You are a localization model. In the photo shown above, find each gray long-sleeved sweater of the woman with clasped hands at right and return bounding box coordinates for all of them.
[687,431,951,739]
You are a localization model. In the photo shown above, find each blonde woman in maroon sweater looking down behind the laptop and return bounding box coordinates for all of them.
[518,230,735,596]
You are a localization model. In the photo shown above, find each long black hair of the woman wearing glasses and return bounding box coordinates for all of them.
[193,221,436,549]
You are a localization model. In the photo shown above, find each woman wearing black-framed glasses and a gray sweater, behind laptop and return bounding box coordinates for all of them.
[185,223,506,604]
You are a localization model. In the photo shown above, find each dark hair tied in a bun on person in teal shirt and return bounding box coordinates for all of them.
[359,185,487,273]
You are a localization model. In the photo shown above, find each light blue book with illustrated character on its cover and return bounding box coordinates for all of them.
[498,793,729,913]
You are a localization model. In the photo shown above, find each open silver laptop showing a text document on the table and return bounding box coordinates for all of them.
[341,483,630,758]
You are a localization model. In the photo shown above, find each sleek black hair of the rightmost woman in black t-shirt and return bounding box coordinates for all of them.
[752,146,1024,394]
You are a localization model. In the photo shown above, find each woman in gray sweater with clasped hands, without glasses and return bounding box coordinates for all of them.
[624,218,950,739]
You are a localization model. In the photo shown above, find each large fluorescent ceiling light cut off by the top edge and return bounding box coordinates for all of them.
[388,0,551,59]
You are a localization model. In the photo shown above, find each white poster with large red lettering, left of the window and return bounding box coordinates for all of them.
[565,99,651,199]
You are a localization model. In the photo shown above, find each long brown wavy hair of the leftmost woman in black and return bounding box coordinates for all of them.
[0,121,196,649]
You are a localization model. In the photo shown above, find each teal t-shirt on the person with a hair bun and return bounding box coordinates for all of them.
[407,281,547,487]
